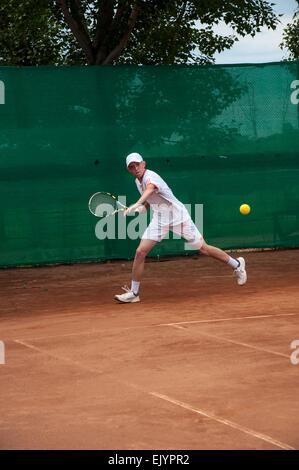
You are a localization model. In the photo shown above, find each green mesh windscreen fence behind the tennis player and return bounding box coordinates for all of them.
[0,62,299,266]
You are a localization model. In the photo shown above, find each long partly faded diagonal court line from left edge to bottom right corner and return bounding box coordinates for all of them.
[15,340,295,450]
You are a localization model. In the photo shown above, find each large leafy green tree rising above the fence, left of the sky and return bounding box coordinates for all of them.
[0,0,278,65]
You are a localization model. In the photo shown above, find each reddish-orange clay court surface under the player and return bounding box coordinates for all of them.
[0,250,299,449]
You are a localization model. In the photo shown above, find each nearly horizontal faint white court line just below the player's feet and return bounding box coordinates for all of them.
[11,313,298,341]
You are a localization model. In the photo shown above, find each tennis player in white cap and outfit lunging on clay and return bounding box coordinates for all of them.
[115,153,247,303]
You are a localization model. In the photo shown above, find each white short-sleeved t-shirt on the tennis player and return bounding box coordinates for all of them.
[135,170,190,226]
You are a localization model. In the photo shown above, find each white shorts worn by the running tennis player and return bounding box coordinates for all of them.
[142,218,203,250]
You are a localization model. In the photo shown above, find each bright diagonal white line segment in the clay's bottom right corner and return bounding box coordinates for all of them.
[149,392,296,450]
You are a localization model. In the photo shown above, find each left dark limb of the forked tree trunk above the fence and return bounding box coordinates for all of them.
[57,0,94,65]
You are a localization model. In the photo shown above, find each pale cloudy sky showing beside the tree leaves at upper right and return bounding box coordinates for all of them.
[214,0,298,64]
